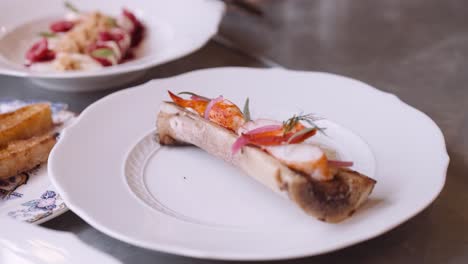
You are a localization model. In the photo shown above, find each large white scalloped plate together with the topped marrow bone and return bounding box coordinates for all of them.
[48,68,449,260]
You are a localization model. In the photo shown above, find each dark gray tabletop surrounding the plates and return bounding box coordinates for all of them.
[0,0,468,264]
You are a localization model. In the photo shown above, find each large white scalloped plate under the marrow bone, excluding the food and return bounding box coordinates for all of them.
[49,68,449,260]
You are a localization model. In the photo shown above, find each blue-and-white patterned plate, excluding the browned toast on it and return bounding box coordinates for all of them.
[0,99,75,224]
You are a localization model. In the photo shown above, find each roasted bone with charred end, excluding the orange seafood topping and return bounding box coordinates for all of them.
[156,102,376,223]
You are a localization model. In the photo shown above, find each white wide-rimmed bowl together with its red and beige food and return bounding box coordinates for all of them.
[0,0,225,91]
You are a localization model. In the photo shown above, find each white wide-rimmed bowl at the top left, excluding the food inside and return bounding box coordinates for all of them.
[0,0,225,91]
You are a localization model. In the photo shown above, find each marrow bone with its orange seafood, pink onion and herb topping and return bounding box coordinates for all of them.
[156,92,376,223]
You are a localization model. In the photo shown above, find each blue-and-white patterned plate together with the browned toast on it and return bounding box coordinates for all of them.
[0,99,75,224]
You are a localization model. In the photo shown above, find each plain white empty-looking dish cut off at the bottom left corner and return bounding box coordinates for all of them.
[0,217,120,264]
